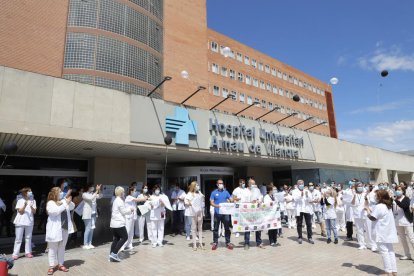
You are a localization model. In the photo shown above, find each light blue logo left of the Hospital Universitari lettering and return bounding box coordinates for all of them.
[165,107,197,145]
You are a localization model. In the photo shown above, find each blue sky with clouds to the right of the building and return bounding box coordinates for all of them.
[207,0,414,151]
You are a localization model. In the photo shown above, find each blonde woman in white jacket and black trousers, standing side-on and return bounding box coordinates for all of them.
[109,186,134,262]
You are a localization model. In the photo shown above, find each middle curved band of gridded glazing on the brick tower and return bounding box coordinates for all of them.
[64,33,162,86]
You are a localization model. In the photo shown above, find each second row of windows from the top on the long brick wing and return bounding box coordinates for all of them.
[211,63,326,111]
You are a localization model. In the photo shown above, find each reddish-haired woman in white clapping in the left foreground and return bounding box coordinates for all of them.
[46,187,75,275]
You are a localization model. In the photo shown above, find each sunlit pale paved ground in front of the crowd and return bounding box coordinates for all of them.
[5,228,414,276]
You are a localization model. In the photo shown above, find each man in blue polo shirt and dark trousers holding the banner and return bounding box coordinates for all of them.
[210,178,234,250]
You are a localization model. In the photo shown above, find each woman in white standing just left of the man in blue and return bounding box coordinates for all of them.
[184,181,204,251]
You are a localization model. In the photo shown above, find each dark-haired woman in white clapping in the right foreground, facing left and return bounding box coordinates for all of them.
[365,190,398,275]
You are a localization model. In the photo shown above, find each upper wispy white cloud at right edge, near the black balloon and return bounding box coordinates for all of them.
[358,43,414,71]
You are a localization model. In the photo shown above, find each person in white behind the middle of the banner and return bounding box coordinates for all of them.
[241,178,264,250]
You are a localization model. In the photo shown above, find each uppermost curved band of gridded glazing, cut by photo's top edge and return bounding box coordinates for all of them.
[68,0,163,52]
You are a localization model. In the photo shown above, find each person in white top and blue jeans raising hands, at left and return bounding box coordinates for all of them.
[82,183,102,249]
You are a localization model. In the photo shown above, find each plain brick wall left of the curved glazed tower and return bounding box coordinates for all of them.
[0,0,68,77]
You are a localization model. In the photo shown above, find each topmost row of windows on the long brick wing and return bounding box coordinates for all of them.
[210,41,325,96]
